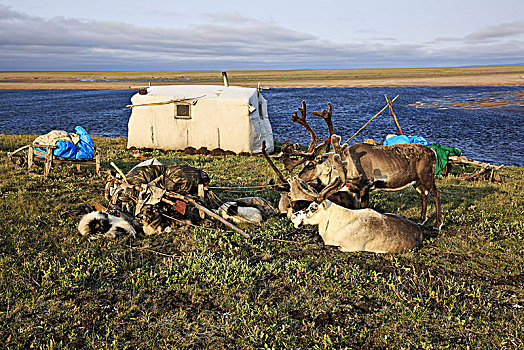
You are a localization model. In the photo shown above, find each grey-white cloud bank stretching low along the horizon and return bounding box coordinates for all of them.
[0,4,524,70]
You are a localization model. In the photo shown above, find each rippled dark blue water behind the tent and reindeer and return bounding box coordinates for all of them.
[0,87,524,166]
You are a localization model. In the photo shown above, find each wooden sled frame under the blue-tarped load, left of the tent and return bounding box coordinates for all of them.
[7,144,100,178]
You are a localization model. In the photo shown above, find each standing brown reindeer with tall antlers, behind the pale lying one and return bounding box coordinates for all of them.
[266,101,442,230]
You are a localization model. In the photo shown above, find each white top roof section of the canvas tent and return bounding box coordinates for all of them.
[147,85,257,100]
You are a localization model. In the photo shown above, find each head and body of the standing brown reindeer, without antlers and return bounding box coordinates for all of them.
[299,135,442,230]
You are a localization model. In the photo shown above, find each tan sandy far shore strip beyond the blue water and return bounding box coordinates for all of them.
[0,66,524,89]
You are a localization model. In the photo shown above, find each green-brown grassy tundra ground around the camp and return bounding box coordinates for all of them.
[0,135,524,349]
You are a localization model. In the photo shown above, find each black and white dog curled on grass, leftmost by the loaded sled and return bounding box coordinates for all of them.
[78,211,136,239]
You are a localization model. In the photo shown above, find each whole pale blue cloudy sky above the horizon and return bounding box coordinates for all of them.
[0,0,524,71]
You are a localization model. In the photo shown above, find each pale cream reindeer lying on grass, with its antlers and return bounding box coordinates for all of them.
[289,155,422,253]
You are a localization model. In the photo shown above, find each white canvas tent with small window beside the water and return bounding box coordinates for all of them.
[127,85,274,153]
